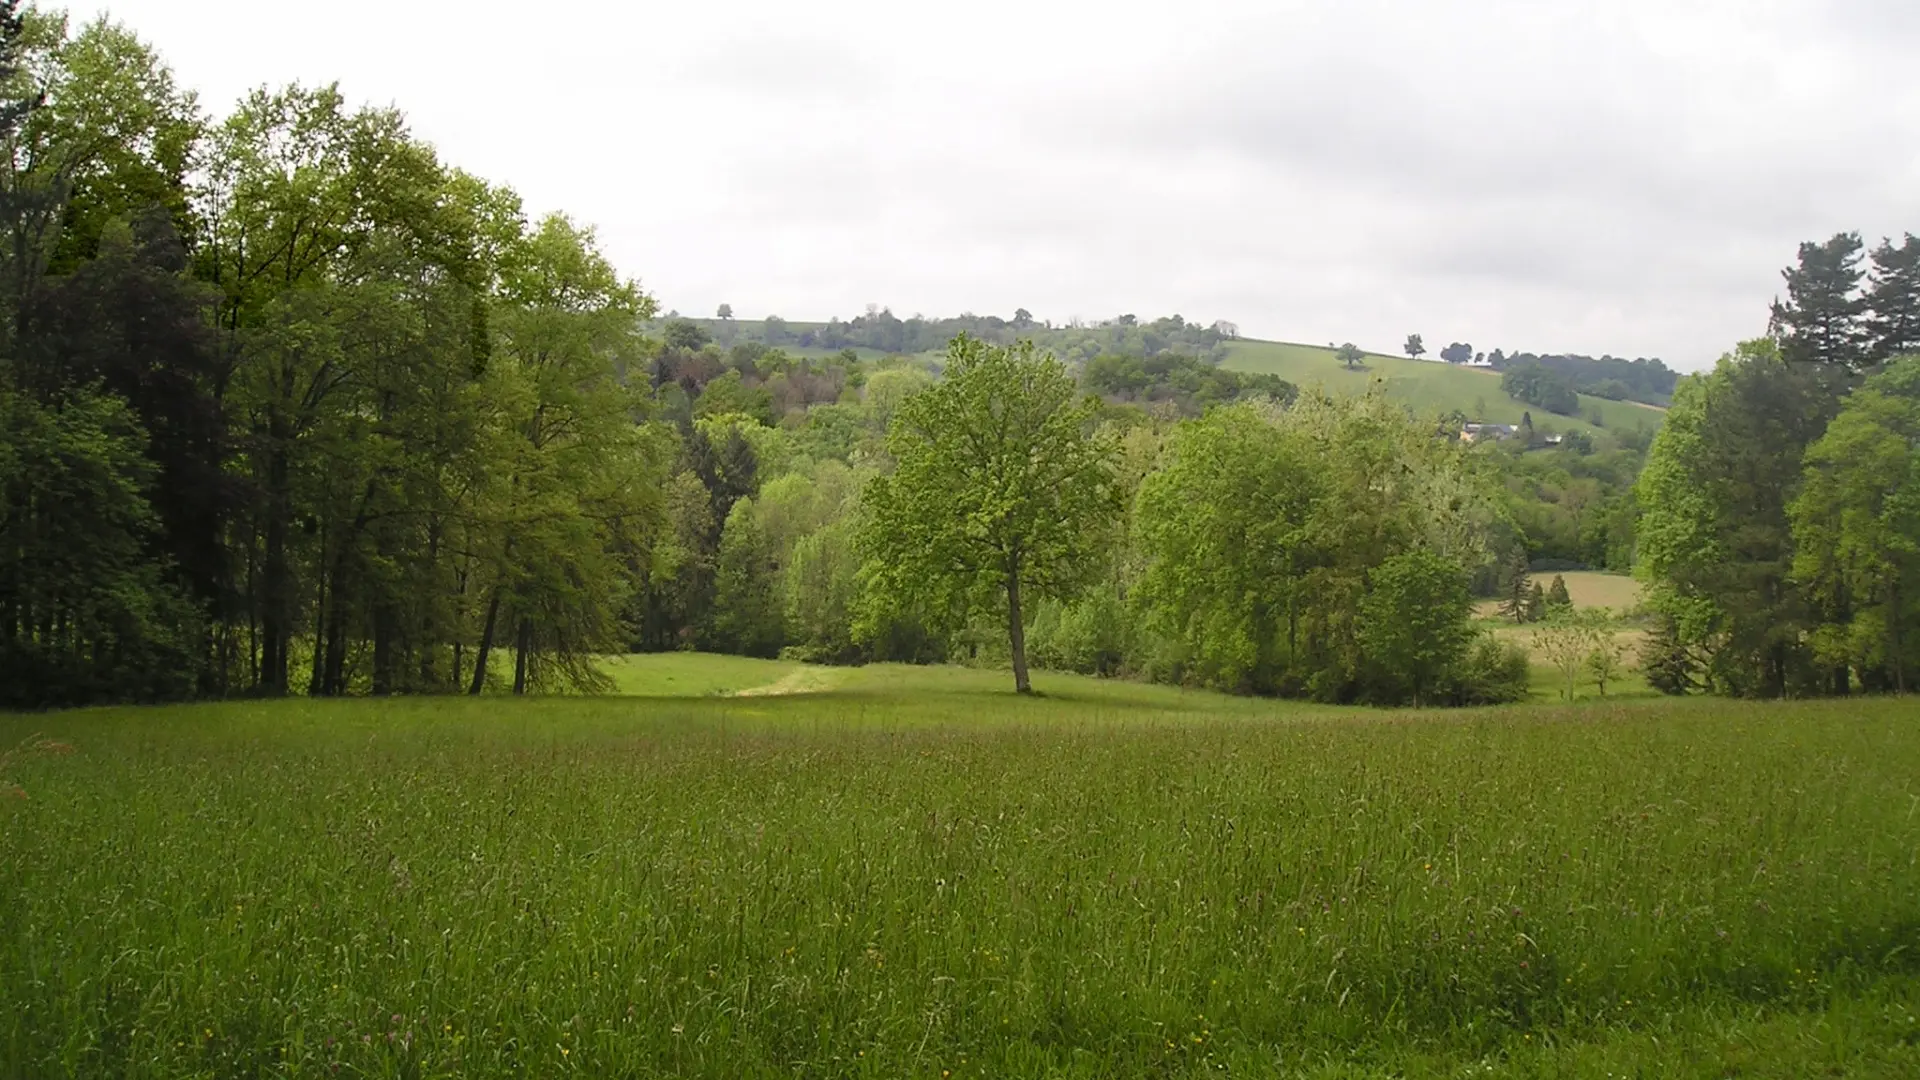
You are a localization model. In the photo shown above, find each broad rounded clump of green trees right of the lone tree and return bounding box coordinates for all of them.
[1133,396,1492,701]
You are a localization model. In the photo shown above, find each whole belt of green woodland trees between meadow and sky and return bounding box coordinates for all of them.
[0,4,1920,707]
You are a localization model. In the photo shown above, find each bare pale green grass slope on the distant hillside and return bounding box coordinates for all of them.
[1223,340,1665,430]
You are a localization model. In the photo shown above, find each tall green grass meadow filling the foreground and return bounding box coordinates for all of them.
[0,657,1920,1080]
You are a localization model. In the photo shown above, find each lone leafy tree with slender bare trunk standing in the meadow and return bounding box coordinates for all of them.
[860,334,1119,694]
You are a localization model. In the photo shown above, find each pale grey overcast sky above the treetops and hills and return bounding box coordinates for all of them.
[73,0,1920,369]
